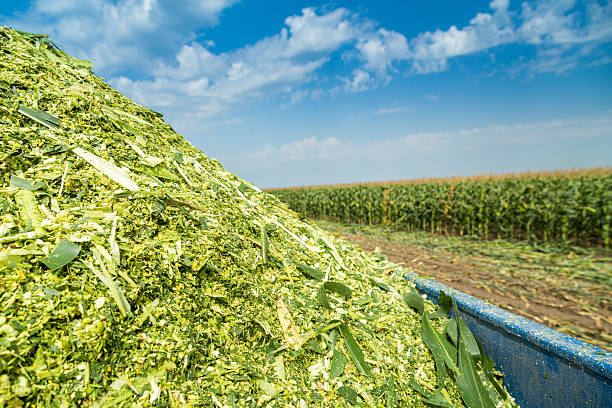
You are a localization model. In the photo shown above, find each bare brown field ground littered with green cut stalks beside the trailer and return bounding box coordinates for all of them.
[315,221,612,351]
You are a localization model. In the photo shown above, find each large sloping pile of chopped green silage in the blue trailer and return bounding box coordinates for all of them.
[0,27,515,408]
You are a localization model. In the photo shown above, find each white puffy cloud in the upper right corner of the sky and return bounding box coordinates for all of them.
[410,0,612,74]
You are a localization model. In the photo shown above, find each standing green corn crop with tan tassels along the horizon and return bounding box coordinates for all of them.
[272,174,612,248]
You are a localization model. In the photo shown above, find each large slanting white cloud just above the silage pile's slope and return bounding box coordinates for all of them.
[110,8,382,124]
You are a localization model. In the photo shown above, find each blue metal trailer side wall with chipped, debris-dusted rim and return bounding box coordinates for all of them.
[406,273,612,408]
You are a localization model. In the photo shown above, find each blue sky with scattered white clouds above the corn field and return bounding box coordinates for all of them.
[0,0,612,187]
